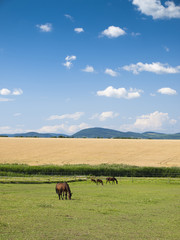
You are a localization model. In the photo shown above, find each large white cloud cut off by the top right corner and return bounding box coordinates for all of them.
[132,0,180,19]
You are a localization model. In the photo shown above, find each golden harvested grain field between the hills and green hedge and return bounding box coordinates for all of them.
[0,138,180,167]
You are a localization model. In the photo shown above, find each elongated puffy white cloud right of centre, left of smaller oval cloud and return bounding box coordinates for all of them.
[97,86,143,99]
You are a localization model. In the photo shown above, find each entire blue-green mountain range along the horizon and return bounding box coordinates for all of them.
[0,127,180,139]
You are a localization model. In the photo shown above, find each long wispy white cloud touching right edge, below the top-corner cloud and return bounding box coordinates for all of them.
[123,62,180,74]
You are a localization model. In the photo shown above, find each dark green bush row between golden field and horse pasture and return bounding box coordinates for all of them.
[0,164,180,177]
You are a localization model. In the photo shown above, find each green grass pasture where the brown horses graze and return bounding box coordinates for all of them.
[0,178,180,240]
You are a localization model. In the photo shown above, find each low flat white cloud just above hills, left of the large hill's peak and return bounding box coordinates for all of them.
[37,123,90,134]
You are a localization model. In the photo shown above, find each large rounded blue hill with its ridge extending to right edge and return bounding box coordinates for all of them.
[72,128,180,139]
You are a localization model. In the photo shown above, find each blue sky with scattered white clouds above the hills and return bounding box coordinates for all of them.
[0,0,180,135]
